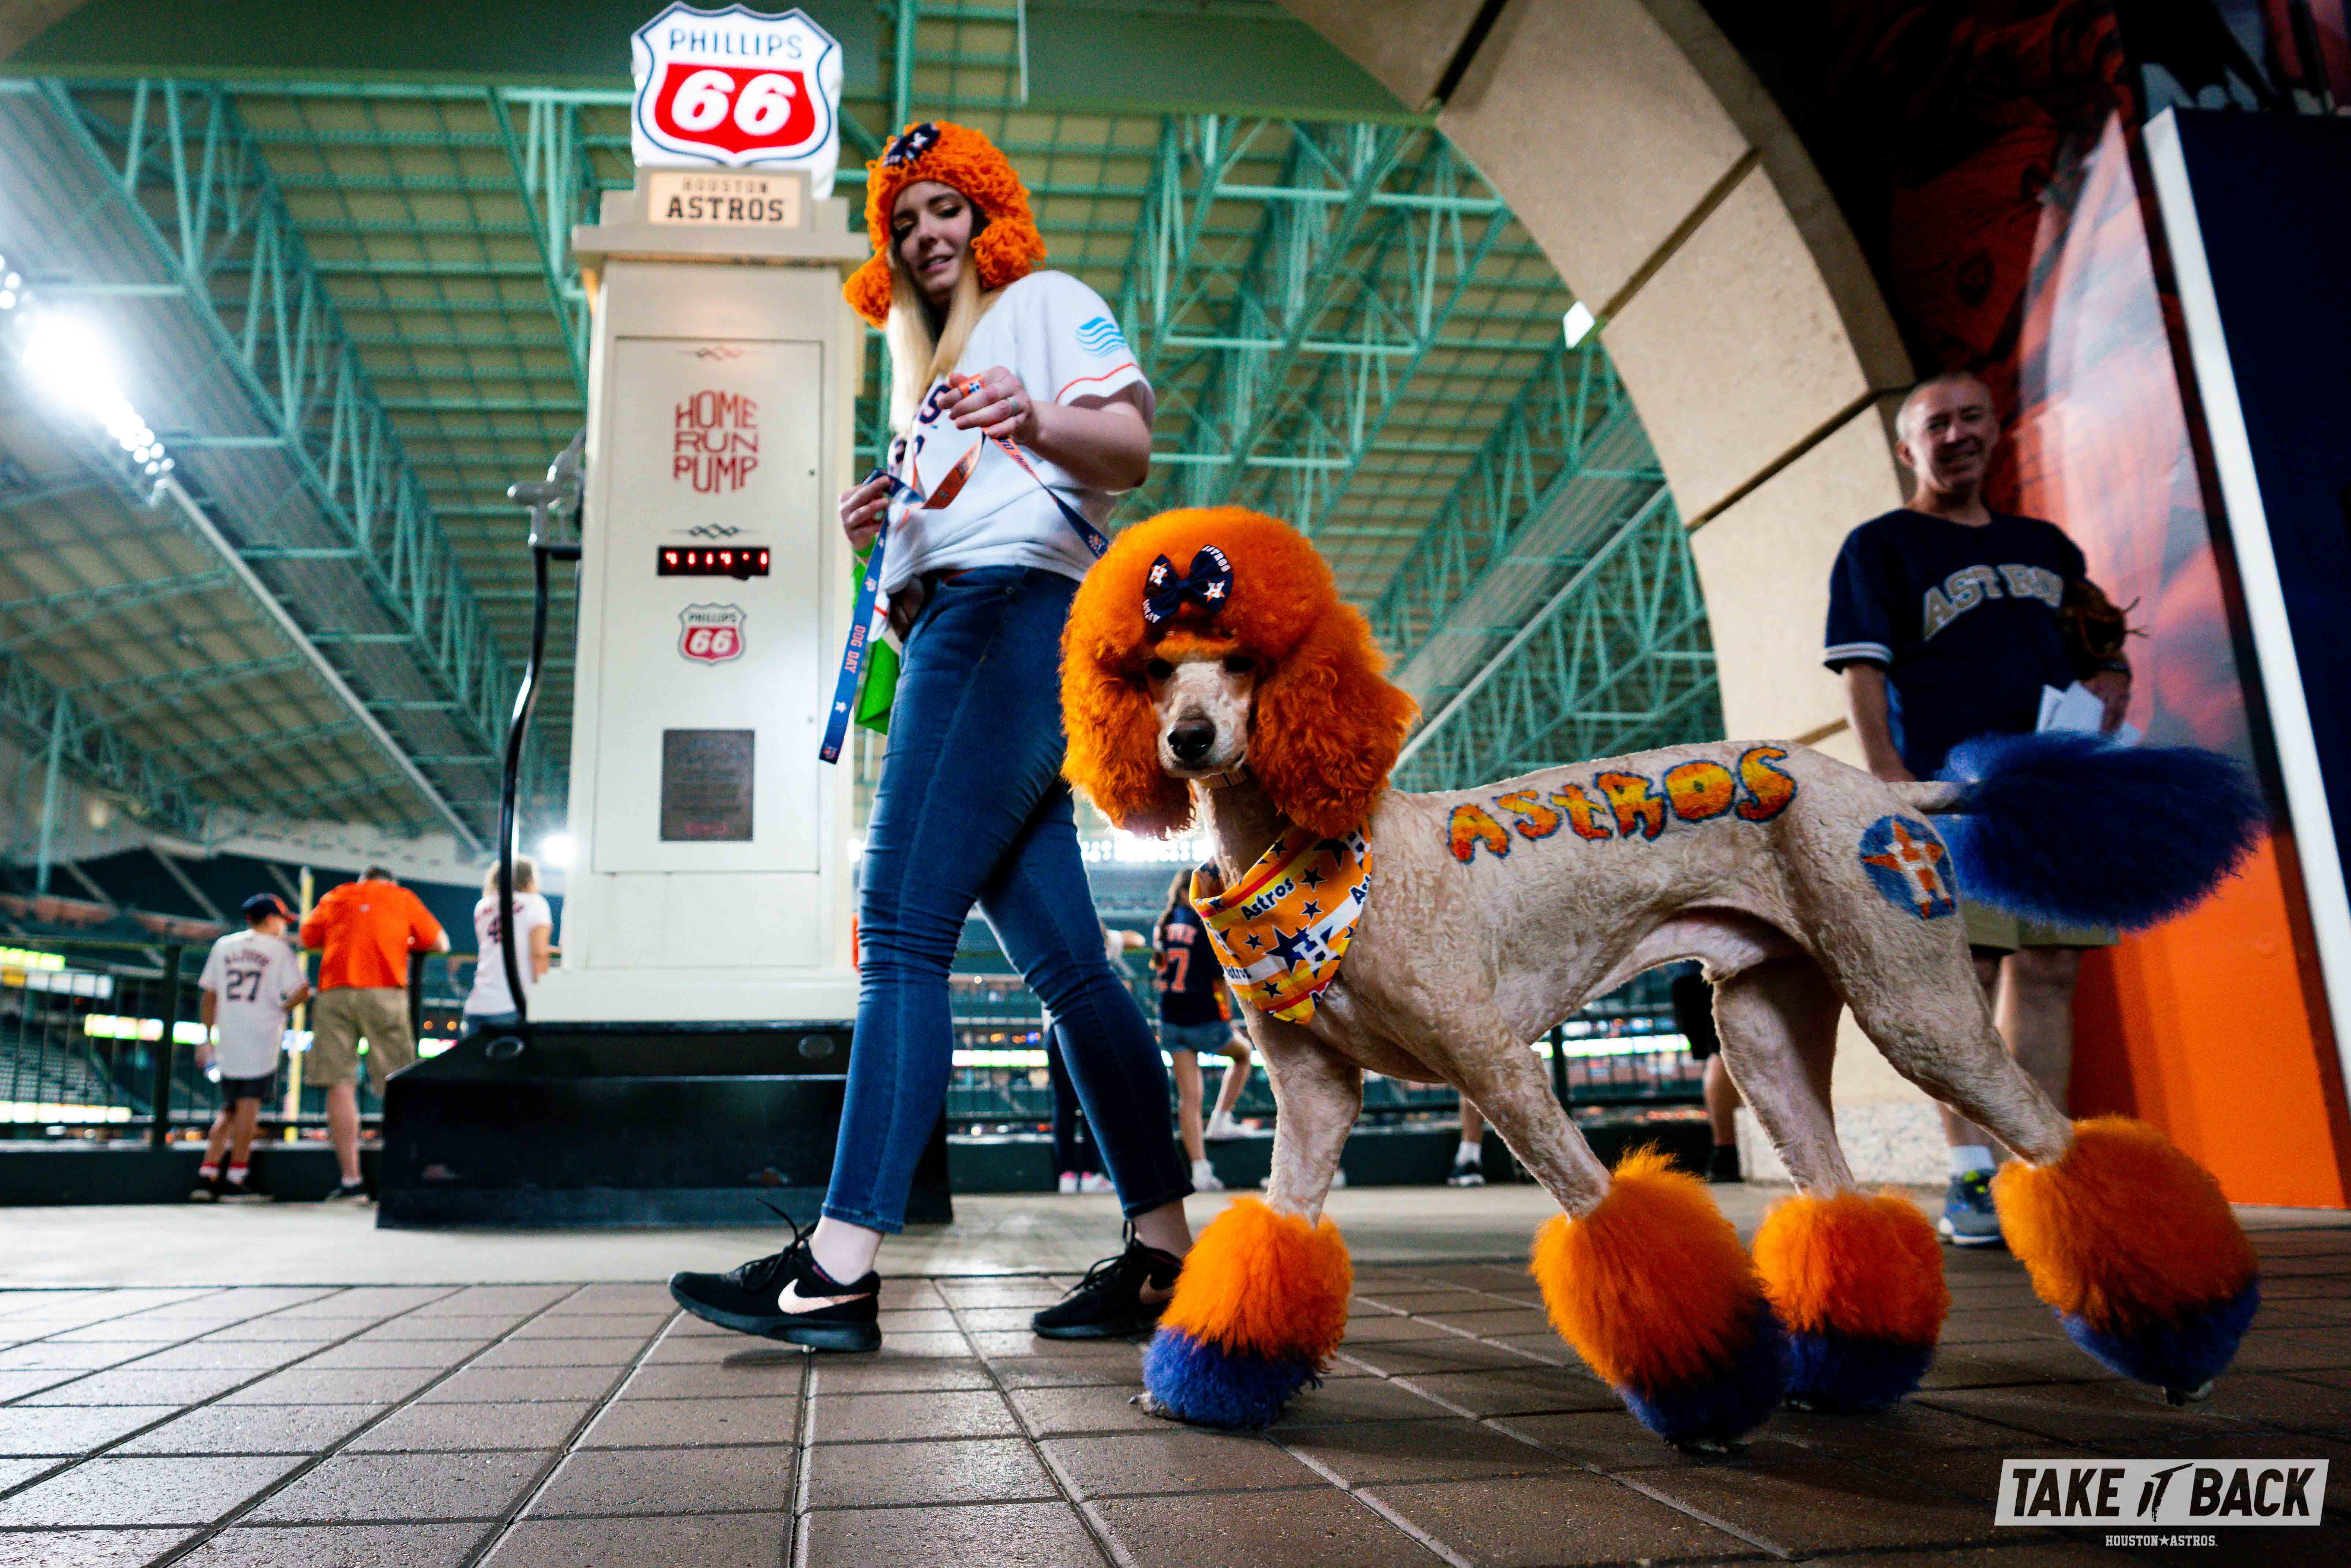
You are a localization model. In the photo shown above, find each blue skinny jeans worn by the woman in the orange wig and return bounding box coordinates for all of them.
[825,567,1192,1232]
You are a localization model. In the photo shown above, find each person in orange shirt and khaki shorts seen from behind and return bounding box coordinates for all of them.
[301,865,449,1204]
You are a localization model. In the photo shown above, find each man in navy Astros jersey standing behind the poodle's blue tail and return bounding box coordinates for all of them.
[1824,372,2130,1246]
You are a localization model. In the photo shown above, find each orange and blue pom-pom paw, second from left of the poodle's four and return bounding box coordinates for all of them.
[1533,1150,1787,1446]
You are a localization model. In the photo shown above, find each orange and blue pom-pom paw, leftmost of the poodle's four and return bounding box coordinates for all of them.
[1143,1196,1354,1427]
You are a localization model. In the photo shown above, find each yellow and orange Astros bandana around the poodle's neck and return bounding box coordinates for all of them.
[1192,827,1371,1023]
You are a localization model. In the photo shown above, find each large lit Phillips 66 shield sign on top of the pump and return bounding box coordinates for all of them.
[630,0,842,198]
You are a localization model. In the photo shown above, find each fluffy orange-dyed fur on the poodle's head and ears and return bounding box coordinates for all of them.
[1060,505,1420,837]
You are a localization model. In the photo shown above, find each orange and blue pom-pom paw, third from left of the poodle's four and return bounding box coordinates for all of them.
[1756,1192,1951,1413]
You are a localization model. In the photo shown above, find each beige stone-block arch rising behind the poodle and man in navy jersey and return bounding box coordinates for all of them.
[1284,0,1944,1182]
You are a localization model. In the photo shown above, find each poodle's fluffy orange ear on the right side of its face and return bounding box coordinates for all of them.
[1248,604,1420,837]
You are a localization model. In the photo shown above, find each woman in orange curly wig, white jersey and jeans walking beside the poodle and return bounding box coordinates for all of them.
[670,120,1192,1349]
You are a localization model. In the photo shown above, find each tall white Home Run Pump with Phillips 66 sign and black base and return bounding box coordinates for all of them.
[379,5,947,1225]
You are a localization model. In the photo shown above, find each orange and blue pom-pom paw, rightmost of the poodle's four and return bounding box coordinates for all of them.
[1991,1117,2262,1394]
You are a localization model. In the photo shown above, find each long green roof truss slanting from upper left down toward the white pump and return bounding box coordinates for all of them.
[14,80,508,837]
